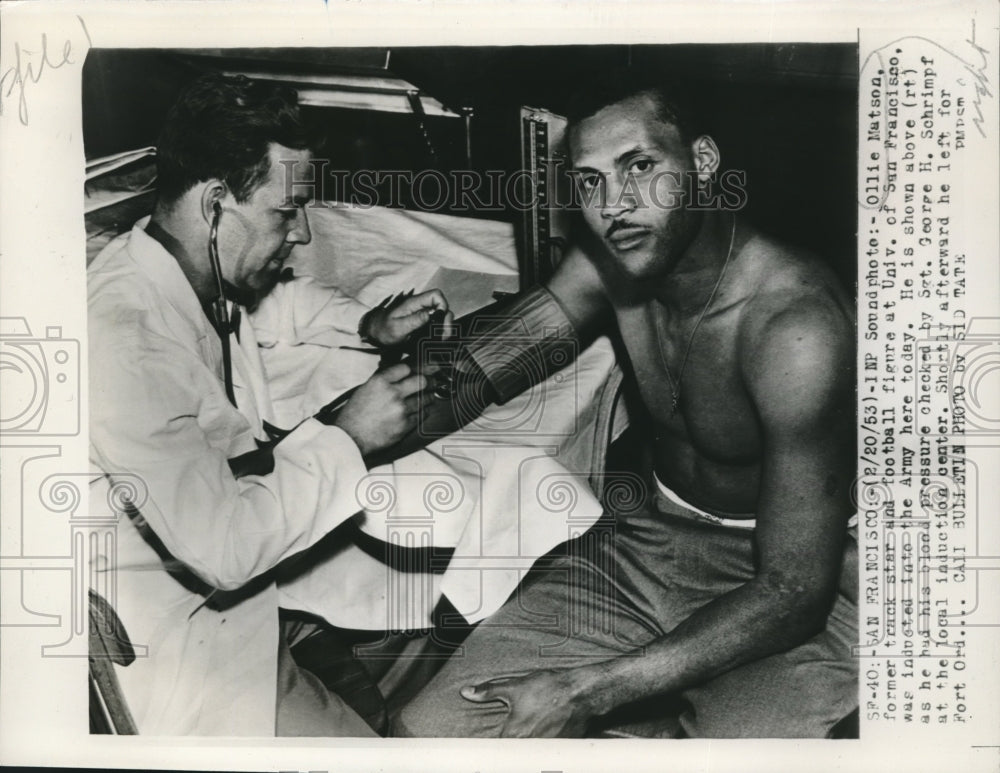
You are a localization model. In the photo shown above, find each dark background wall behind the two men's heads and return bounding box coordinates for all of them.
[83,44,858,285]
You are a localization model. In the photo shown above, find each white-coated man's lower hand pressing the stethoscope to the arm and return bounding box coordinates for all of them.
[334,364,430,456]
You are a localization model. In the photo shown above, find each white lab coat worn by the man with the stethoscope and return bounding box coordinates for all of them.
[88,223,366,736]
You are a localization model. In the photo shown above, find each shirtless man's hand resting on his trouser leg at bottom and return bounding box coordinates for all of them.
[461,669,593,738]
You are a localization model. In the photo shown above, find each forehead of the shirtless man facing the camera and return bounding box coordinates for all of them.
[569,93,683,169]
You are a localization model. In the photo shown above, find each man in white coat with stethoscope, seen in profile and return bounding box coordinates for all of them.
[88,76,447,736]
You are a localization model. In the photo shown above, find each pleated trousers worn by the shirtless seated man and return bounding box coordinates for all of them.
[393,486,858,738]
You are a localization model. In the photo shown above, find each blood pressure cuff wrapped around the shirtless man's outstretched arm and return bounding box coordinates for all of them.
[462,287,580,405]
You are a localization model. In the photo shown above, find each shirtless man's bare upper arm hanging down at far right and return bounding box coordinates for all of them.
[743,303,855,606]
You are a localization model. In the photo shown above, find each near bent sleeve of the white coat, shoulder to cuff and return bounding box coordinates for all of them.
[89,308,367,590]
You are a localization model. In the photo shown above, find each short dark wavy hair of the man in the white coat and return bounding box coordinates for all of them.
[157,73,311,203]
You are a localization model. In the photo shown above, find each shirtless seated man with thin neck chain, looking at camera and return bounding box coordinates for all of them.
[397,77,857,737]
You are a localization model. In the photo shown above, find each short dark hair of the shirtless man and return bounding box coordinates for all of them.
[566,67,707,143]
